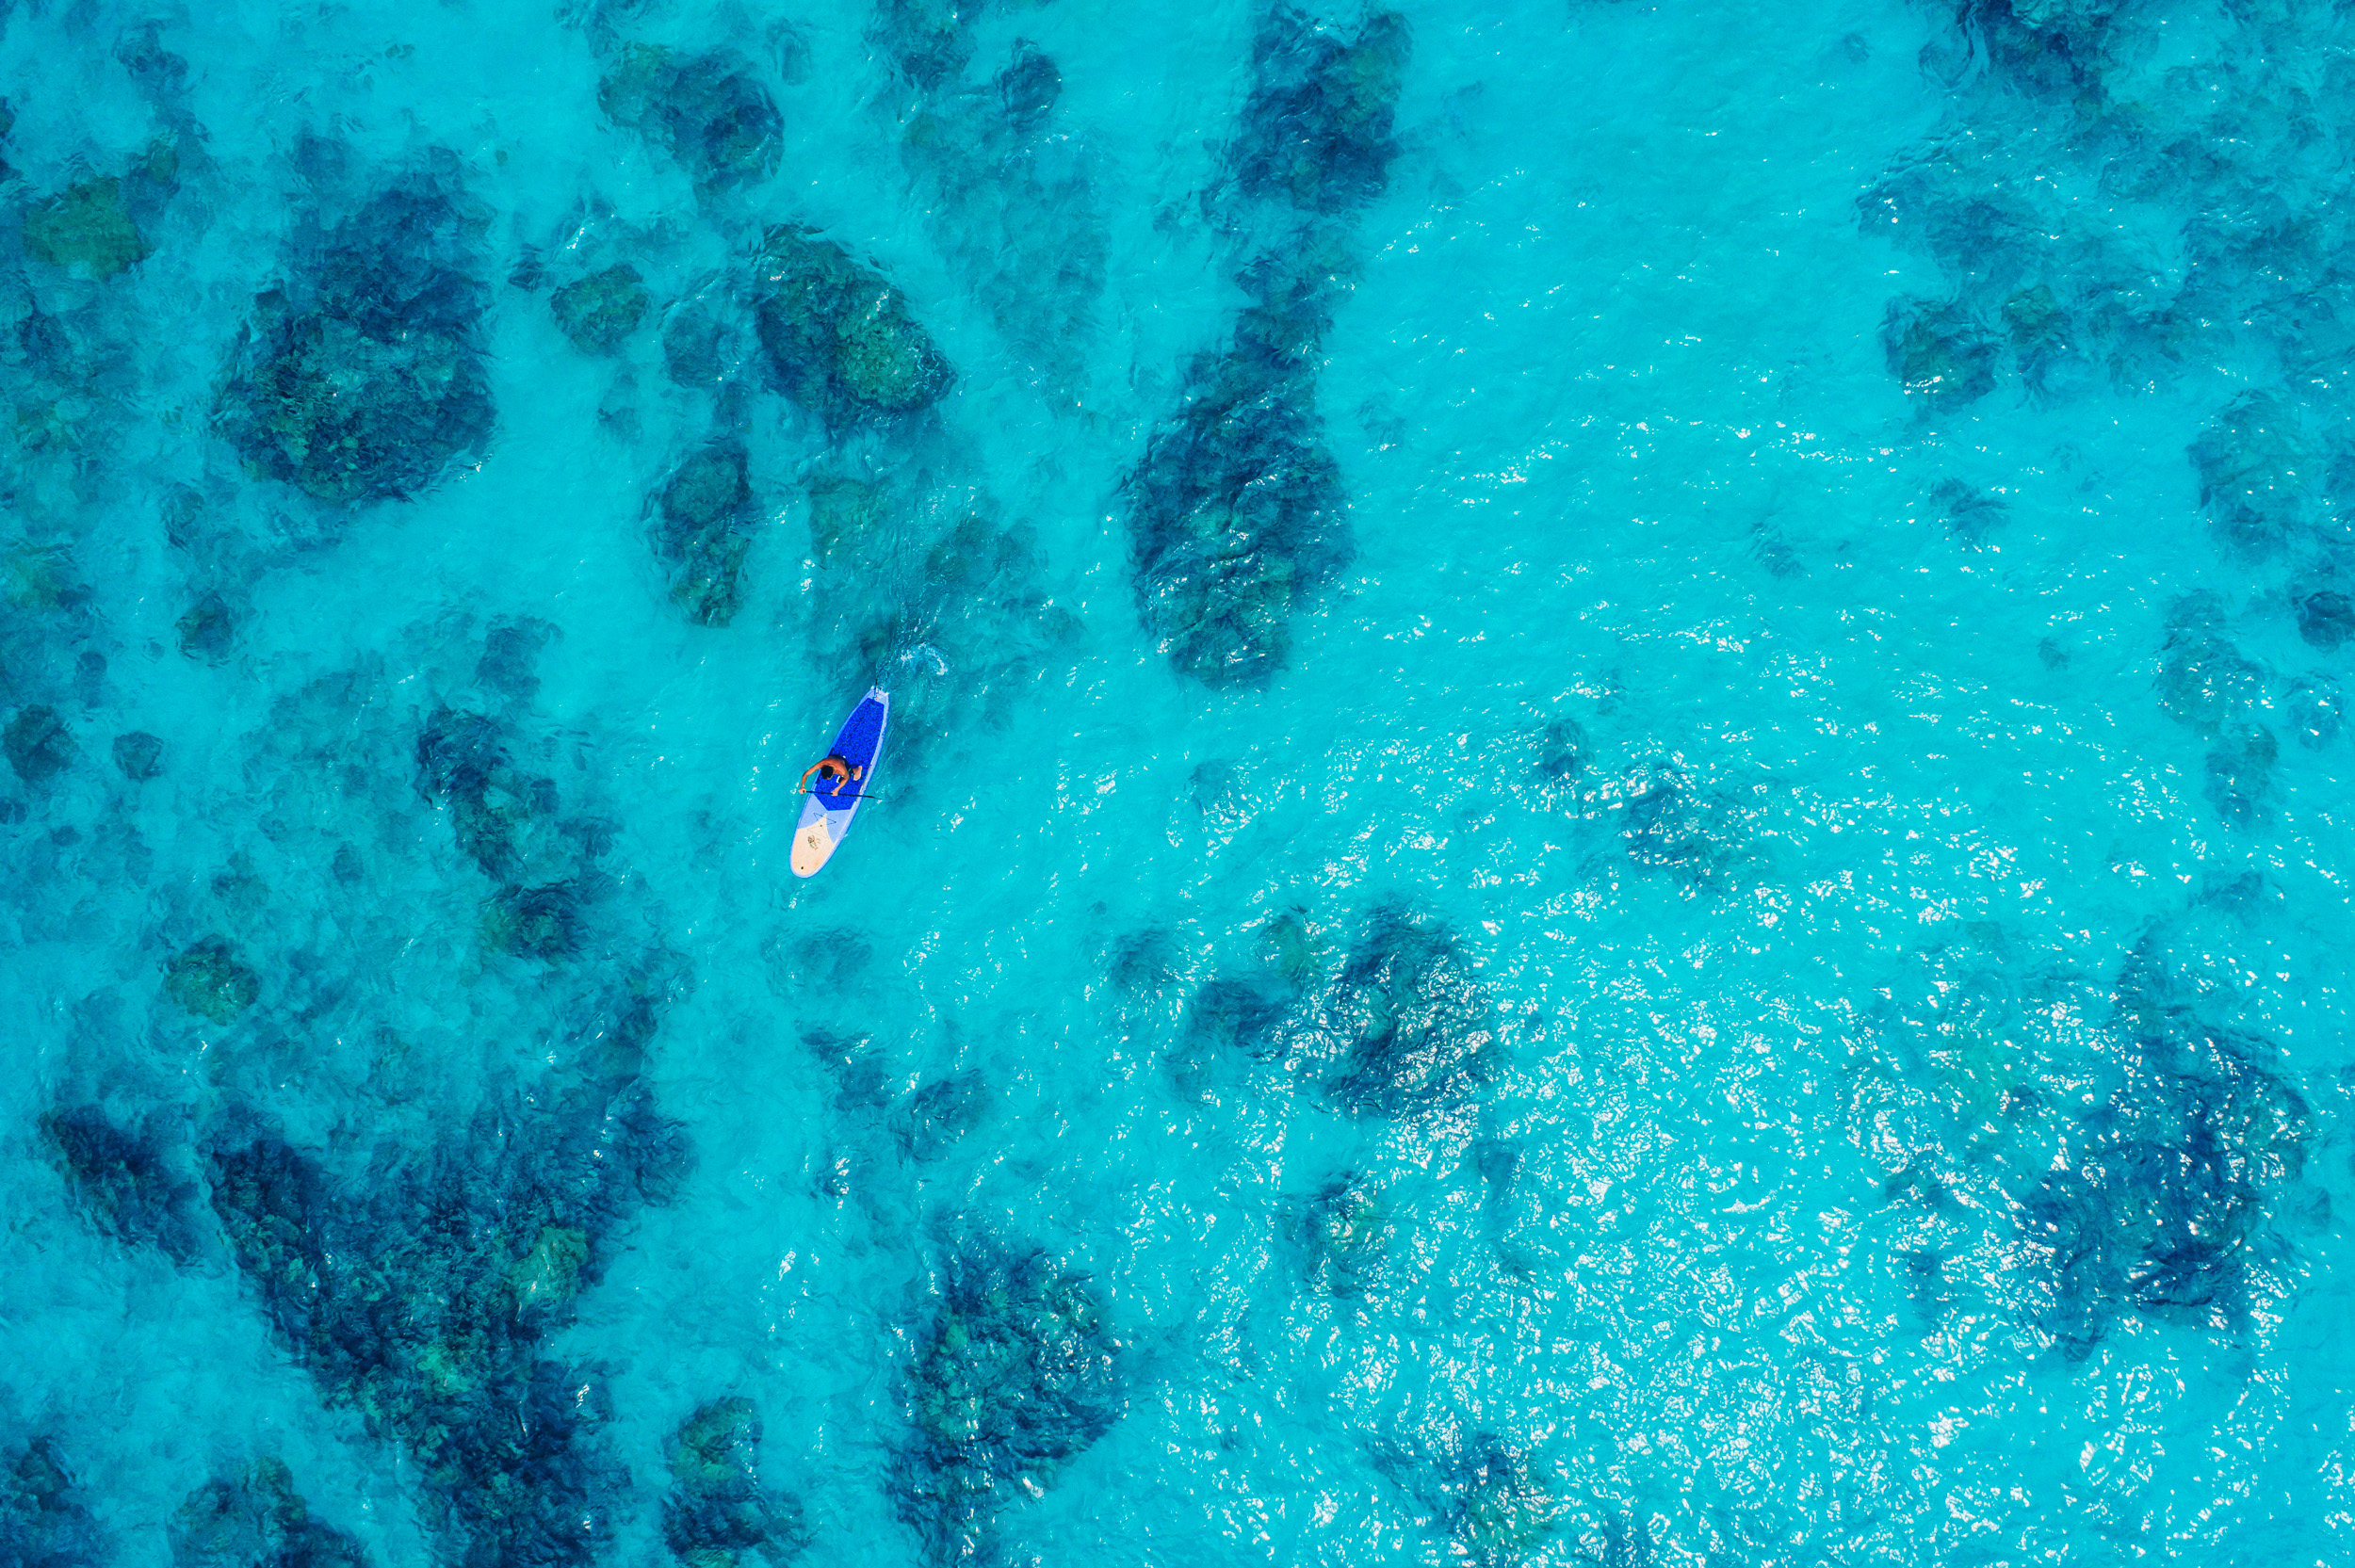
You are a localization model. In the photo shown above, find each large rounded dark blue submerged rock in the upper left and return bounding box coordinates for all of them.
[212,182,493,507]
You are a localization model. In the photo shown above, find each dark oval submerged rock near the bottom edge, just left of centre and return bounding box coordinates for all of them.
[898,1246,1121,1561]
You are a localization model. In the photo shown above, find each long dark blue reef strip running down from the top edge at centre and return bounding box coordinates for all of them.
[1124,8,1408,687]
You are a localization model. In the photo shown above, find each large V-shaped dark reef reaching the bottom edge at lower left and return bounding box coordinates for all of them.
[210,1069,681,1568]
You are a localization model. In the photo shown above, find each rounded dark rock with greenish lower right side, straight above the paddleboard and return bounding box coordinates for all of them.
[754,224,956,428]
